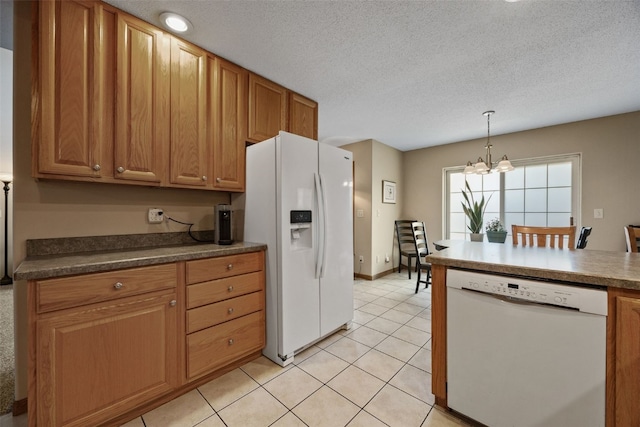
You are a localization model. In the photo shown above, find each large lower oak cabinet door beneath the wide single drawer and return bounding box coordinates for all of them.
[36,291,179,426]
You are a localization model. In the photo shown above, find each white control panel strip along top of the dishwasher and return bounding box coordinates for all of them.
[447,269,607,314]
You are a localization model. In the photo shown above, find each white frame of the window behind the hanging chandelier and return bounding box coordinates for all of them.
[442,153,582,239]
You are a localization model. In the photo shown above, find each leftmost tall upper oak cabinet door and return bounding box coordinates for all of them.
[34,1,106,178]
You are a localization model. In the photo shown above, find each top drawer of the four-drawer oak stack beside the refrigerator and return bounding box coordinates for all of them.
[187,252,264,285]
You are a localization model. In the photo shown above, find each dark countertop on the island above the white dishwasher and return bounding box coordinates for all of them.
[427,242,640,290]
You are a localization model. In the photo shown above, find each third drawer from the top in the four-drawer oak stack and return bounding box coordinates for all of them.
[187,292,264,333]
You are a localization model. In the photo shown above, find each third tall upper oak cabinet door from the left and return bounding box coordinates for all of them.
[169,37,209,187]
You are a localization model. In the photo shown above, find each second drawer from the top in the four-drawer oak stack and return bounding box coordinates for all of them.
[187,271,264,308]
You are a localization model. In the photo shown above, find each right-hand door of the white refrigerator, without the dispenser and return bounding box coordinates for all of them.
[318,144,353,336]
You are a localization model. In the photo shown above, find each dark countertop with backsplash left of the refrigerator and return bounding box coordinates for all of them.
[13,233,267,280]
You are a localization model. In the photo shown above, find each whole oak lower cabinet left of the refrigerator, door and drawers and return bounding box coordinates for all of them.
[27,251,265,427]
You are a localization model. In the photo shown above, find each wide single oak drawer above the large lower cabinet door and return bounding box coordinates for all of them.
[36,264,178,313]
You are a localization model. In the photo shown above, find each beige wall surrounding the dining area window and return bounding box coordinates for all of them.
[403,112,640,251]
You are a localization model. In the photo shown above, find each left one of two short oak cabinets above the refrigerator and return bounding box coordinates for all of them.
[247,73,287,142]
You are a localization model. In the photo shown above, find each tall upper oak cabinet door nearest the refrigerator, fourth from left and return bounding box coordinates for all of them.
[209,57,249,191]
